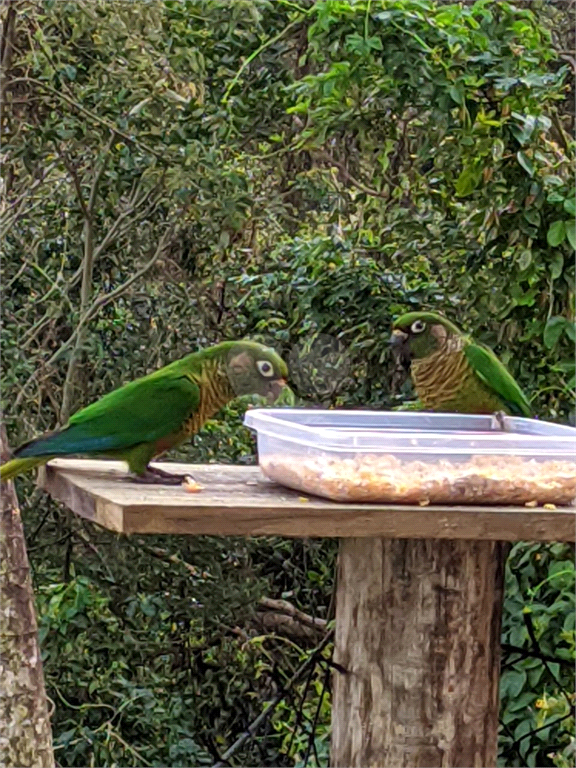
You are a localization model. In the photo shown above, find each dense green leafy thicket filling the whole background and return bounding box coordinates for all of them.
[0,0,575,766]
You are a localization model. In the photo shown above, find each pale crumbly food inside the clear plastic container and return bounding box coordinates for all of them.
[260,453,576,506]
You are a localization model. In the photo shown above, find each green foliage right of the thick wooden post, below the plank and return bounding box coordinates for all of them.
[500,544,576,766]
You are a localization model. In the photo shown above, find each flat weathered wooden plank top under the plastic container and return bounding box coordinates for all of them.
[39,459,576,541]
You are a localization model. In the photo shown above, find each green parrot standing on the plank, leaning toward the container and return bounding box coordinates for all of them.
[0,341,288,485]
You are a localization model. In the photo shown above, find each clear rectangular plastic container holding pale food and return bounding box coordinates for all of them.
[244,408,576,506]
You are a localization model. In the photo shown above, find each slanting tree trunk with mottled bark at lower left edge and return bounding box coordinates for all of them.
[0,427,54,768]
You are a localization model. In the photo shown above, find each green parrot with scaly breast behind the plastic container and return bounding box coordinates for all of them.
[390,312,532,416]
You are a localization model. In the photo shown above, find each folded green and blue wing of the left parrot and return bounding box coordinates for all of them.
[14,376,200,458]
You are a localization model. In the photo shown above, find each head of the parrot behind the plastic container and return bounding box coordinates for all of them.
[390,312,462,360]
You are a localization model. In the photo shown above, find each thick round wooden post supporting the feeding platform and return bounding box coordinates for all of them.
[331,538,508,768]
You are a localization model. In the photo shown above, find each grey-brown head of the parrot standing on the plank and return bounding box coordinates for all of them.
[226,341,288,403]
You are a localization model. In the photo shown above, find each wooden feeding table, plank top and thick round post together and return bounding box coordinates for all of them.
[40,459,575,768]
